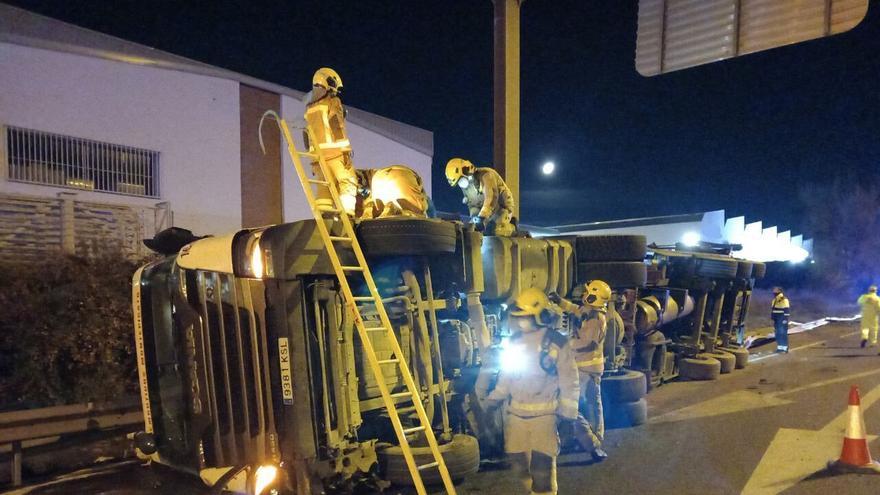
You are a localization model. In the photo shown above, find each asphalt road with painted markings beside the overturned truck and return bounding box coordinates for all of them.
[3,324,880,495]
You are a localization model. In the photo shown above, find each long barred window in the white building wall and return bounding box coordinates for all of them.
[6,127,159,198]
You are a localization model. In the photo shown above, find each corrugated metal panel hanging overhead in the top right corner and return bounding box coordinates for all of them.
[636,0,868,76]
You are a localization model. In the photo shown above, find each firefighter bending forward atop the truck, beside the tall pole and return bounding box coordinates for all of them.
[446,158,515,236]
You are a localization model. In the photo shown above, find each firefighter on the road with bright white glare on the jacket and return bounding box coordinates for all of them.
[487,289,579,494]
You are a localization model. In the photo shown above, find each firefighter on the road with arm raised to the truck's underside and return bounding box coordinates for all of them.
[550,280,611,461]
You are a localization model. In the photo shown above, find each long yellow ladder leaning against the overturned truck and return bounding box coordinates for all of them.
[260,110,455,495]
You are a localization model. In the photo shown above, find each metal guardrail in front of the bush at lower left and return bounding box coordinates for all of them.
[0,400,144,486]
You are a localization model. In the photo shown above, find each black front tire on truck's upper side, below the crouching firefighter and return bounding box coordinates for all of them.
[357,217,455,256]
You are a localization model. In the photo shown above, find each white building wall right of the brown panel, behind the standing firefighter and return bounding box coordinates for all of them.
[280,96,431,222]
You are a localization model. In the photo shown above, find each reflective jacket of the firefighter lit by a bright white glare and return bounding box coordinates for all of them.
[487,318,580,419]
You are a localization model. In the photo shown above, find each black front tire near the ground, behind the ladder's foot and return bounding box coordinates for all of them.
[377,434,480,486]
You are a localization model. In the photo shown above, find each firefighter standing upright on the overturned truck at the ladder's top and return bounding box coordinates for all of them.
[303,67,358,215]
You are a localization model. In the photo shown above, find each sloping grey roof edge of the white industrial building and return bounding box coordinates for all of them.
[0,3,434,156]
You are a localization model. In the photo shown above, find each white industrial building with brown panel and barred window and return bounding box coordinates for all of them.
[0,4,433,259]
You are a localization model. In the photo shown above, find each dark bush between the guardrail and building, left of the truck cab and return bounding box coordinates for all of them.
[0,254,144,409]
